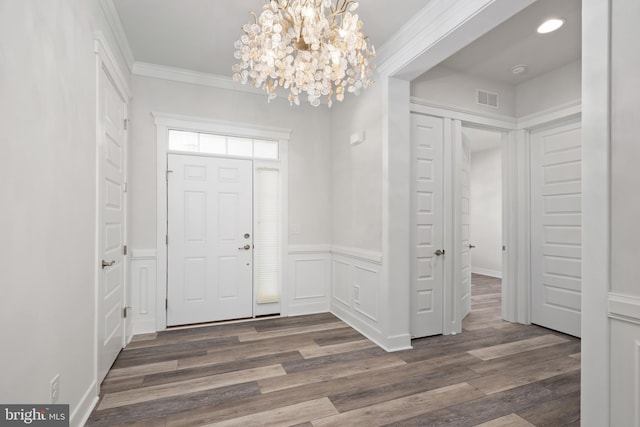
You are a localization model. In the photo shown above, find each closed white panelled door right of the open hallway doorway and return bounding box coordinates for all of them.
[531,122,582,336]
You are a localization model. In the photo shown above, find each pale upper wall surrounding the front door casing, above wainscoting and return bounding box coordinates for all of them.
[130,76,331,249]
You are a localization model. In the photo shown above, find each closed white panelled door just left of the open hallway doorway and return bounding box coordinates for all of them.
[411,114,444,338]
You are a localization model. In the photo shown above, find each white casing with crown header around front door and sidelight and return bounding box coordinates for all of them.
[152,112,291,331]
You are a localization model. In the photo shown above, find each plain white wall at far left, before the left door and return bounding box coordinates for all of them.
[0,0,131,425]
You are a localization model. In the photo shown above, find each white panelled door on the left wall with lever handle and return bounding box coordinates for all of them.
[98,70,126,382]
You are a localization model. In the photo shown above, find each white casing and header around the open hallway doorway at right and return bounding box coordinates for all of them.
[410,98,581,335]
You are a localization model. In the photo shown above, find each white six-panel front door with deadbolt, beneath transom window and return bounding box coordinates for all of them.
[167,154,253,326]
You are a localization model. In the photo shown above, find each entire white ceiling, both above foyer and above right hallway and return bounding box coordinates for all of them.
[113,0,581,84]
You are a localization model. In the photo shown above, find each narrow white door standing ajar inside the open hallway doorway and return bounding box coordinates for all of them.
[458,132,471,320]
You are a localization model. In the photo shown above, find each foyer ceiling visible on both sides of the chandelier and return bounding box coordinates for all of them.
[114,0,429,77]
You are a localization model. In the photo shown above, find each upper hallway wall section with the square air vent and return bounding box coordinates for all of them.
[411,65,516,117]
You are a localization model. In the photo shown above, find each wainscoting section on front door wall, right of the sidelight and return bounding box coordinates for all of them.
[288,246,331,316]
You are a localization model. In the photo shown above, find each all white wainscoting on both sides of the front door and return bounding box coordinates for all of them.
[130,245,387,348]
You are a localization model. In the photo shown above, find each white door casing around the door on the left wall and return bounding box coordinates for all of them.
[94,32,133,393]
